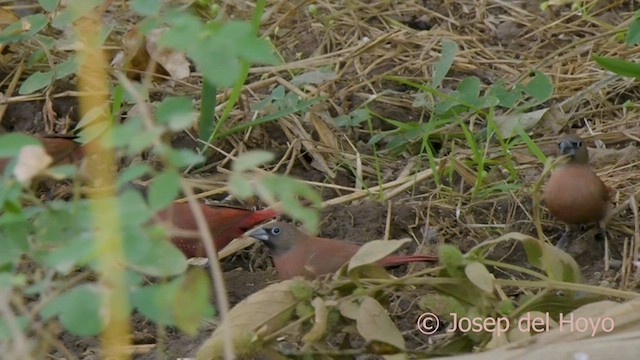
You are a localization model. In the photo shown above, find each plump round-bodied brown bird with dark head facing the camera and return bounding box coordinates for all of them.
[543,134,614,226]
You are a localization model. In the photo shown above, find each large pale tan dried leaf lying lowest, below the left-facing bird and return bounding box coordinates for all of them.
[196,280,298,360]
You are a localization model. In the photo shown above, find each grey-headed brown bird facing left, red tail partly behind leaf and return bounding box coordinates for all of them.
[249,222,438,279]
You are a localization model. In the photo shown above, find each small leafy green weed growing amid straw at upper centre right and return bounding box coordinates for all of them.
[336,40,553,193]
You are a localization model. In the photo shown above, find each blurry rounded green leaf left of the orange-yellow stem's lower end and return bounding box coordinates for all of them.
[40,284,105,336]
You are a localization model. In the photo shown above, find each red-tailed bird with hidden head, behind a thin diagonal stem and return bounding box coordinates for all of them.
[154,202,279,258]
